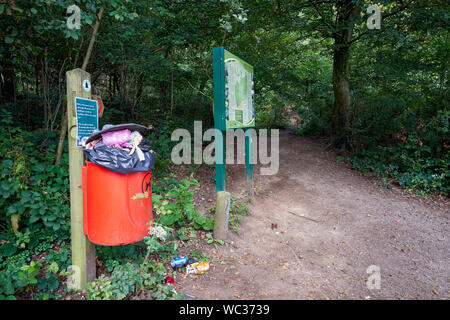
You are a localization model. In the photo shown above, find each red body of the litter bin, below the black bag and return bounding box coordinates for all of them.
[82,161,153,246]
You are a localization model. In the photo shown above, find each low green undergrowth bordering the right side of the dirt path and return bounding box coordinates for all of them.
[346,111,450,195]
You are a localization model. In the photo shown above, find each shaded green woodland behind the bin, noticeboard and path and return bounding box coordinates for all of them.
[0,0,450,235]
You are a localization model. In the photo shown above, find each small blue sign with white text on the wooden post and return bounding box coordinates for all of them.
[75,97,98,147]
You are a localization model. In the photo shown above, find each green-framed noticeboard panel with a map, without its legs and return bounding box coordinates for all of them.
[213,47,255,130]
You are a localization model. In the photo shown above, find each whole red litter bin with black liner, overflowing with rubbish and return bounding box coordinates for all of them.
[82,124,154,246]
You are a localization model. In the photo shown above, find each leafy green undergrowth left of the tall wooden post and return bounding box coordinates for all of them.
[0,111,70,299]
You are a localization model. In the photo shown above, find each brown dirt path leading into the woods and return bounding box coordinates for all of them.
[178,132,450,299]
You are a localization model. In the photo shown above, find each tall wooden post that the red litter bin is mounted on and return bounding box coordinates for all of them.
[66,69,96,290]
